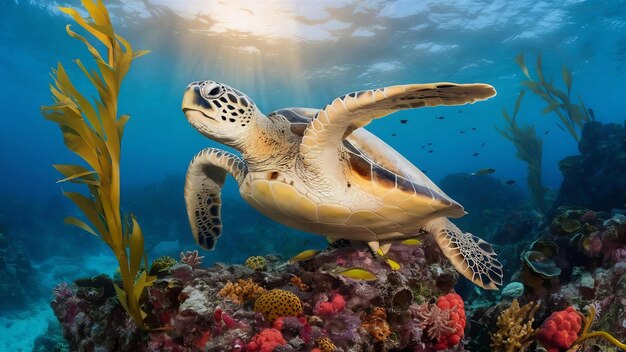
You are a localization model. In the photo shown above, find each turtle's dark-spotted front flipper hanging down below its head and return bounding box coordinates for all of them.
[185,148,247,250]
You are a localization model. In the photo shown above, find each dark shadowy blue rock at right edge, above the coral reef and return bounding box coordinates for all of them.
[553,122,626,212]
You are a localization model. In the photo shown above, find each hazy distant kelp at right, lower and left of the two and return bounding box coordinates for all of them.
[496,90,548,214]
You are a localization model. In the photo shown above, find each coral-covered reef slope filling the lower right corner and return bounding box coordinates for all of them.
[467,207,626,351]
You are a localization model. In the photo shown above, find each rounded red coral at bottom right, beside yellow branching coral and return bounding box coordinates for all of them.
[537,306,582,352]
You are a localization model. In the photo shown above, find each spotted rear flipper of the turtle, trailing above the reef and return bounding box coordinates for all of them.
[424,217,502,290]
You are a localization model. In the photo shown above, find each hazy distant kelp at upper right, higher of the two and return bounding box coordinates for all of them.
[515,54,594,142]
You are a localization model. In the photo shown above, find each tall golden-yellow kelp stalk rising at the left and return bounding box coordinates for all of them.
[42,0,154,328]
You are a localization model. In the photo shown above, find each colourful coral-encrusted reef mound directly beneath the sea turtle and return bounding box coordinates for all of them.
[51,238,466,352]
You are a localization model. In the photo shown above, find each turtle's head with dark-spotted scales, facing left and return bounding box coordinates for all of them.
[182,81,260,148]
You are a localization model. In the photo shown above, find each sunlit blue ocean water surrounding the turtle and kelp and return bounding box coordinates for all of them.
[0,0,626,350]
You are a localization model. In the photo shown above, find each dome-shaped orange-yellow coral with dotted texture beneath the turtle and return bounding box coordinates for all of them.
[254,289,303,321]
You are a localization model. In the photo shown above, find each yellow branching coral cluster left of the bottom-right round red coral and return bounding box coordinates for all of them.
[491,299,539,352]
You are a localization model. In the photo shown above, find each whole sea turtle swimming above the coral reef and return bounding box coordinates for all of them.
[182,81,502,289]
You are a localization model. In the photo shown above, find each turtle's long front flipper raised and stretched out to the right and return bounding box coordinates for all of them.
[300,82,496,175]
